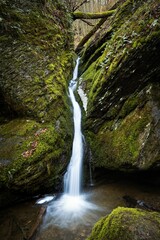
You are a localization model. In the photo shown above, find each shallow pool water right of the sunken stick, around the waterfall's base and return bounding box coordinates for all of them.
[36,176,160,240]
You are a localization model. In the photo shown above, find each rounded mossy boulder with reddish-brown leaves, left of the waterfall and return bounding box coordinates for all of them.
[0,119,71,194]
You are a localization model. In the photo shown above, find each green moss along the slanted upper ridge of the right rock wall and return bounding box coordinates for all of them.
[83,1,159,114]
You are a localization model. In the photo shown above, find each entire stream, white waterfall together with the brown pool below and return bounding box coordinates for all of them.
[0,58,160,240]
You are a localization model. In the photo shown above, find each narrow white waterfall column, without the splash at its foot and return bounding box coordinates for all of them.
[64,58,83,196]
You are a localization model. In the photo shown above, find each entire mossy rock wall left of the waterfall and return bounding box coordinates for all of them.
[0,0,73,194]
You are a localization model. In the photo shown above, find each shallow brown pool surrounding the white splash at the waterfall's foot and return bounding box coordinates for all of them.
[0,174,160,240]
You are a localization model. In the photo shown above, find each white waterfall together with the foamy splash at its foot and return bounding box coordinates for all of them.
[38,58,97,229]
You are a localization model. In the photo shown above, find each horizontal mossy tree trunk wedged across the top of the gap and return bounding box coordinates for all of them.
[72,10,116,20]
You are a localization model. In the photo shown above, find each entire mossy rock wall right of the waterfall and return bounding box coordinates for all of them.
[81,0,160,170]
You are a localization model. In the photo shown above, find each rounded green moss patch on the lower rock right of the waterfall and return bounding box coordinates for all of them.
[113,108,149,161]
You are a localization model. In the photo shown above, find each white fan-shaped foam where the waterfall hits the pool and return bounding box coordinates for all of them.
[43,194,101,229]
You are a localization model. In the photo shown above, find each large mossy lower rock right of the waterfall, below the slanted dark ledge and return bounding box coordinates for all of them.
[86,84,160,171]
